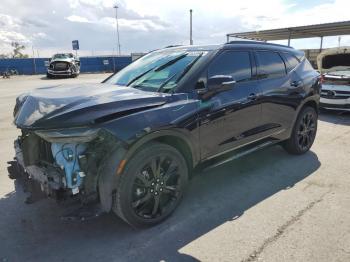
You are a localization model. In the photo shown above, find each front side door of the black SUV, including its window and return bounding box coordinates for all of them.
[200,50,261,158]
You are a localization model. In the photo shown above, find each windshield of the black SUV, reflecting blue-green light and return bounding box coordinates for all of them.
[106,50,204,92]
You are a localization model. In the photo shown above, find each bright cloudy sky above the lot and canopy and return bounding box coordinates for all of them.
[0,0,350,57]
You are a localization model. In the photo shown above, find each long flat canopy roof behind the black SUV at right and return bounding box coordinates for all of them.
[227,21,350,41]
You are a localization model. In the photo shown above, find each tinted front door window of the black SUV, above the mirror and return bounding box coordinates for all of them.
[209,51,252,81]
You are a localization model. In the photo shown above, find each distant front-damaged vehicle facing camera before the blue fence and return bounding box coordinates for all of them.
[46,53,80,78]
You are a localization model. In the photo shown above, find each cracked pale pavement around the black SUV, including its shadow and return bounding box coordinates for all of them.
[0,74,350,262]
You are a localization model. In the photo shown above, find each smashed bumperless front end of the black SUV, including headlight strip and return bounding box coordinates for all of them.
[8,128,119,219]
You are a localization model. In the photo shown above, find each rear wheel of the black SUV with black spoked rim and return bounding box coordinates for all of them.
[282,106,318,155]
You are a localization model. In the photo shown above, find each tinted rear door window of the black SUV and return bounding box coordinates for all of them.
[256,51,286,78]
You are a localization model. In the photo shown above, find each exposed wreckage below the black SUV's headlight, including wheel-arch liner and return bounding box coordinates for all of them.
[8,129,126,220]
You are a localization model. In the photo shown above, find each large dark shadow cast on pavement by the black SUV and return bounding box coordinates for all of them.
[0,146,320,261]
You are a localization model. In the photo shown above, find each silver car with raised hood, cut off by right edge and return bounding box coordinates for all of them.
[317,47,350,111]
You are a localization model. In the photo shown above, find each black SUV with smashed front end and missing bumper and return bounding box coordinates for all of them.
[8,41,320,226]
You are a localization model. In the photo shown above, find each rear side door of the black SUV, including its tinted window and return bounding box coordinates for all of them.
[255,50,302,135]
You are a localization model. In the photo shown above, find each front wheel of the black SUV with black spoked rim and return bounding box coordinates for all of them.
[113,142,188,227]
